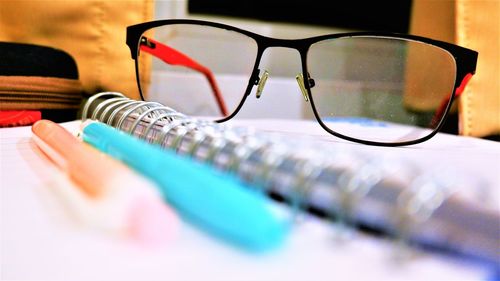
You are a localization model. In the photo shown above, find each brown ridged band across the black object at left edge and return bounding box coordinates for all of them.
[0,76,82,110]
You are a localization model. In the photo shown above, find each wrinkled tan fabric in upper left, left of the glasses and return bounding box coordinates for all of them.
[0,0,154,98]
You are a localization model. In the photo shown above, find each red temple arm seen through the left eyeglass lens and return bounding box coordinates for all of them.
[140,36,228,116]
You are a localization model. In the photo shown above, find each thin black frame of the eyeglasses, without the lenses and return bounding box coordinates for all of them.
[126,19,478,146]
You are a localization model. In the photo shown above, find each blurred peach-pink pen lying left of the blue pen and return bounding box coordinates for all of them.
[32,120,178,245]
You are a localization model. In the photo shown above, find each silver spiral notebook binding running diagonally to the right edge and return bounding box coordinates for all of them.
[82,92,500,266]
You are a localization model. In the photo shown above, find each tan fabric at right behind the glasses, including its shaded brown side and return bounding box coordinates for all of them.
[410,0,500,137]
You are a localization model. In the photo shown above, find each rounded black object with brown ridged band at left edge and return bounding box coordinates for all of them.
[0,42,82,122]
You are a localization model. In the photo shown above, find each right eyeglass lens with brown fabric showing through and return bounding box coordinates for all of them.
[307,37,456,142]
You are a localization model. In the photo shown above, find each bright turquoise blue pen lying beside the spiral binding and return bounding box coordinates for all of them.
[82,122,289,251]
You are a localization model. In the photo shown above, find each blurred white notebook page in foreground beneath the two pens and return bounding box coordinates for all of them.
[0,122,489,280]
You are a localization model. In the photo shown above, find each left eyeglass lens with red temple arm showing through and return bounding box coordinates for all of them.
[138,24,257,120]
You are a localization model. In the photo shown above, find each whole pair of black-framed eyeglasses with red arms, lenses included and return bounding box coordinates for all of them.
[127,19,478,146]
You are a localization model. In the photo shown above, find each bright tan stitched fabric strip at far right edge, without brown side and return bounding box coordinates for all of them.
[456,0,500,136]
